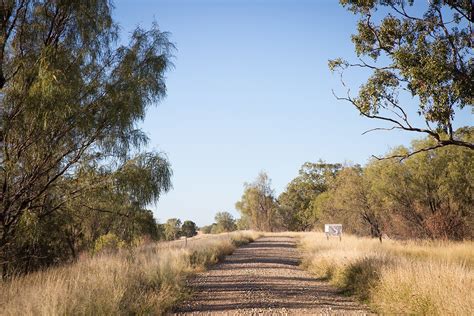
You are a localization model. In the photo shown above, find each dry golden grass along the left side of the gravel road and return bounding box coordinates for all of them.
[0,232,257,315]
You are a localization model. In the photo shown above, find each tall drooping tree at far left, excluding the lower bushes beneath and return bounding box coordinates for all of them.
[0,0,173,274]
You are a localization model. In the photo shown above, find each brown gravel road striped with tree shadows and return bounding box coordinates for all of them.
[175,236,368,315]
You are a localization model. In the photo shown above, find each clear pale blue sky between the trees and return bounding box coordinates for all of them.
[114,0,472,225]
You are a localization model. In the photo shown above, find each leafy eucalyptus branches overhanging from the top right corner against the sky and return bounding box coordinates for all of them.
[329,0,474,158]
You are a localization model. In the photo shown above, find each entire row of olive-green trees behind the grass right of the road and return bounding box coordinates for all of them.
[236,127,474,240]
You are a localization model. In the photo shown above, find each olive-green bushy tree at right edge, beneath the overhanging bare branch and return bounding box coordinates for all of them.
[366,129,474,240]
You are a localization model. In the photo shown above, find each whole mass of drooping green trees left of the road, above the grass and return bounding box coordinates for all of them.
[0,0,173,276]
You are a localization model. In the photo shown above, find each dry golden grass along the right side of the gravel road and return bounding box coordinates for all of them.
[301,233,474,315]
